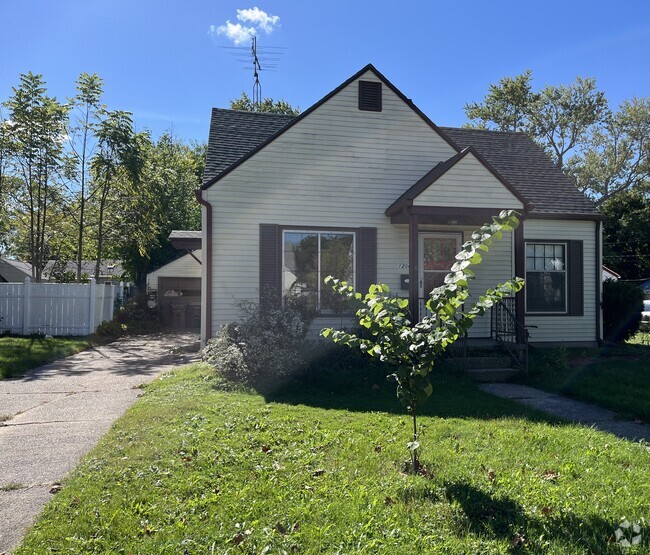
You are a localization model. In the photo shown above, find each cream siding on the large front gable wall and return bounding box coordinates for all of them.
[204,73,455,334]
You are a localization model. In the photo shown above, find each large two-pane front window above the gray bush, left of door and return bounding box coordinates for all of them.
[282,229,356,314]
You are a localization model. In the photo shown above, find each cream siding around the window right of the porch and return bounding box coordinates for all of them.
[524,220,596,342]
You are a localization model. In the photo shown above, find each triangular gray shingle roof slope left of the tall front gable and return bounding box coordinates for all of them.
[203,108,295,183]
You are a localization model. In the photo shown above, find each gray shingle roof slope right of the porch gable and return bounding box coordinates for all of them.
[441,127,598,216]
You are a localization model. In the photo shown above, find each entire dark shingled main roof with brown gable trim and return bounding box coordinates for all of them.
[202,64,602,220]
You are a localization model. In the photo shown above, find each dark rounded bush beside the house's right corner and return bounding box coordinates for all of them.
[603,280,643,343]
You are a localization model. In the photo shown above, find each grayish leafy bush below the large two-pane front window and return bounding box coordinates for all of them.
[202,300,313,388]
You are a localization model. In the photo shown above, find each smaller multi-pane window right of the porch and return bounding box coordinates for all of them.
[526,242,568,314]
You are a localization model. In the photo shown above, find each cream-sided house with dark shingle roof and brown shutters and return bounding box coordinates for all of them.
[199,65,602,345]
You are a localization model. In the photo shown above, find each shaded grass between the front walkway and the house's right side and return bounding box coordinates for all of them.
[524,334,650,422]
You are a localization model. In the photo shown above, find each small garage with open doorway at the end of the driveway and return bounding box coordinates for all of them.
[147,231,202,329]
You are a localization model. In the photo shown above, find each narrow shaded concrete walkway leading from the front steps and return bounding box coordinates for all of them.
[481,383,650,441]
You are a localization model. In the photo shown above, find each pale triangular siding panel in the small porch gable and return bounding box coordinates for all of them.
[413,152,522,210]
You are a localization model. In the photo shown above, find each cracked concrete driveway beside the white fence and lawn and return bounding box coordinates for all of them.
[0,334,198,554]
